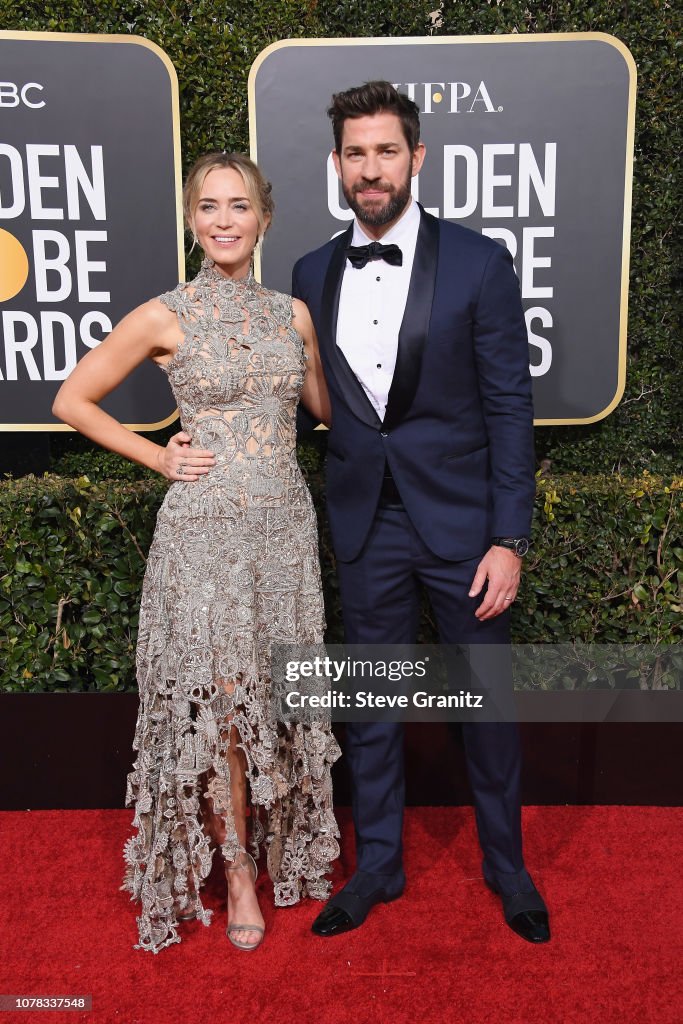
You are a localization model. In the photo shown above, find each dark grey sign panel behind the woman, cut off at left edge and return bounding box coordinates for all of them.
[0,33,184,430]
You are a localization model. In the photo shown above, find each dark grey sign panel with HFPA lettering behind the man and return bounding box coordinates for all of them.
[249,33,636,424]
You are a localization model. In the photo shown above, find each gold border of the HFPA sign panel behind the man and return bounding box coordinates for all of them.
[248,32,638,427]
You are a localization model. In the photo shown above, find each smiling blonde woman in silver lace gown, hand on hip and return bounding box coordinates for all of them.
[54,154,339,952]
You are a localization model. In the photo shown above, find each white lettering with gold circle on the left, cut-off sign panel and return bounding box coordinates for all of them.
[0,143,112,381]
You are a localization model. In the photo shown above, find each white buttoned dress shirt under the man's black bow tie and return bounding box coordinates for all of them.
[337,200,420,420]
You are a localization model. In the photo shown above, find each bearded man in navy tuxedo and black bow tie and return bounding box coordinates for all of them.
[293,82,550,942]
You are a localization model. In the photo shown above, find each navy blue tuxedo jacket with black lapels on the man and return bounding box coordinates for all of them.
[292,209,535,561]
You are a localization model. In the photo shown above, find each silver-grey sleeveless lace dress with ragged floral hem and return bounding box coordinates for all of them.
[122,260,340,952]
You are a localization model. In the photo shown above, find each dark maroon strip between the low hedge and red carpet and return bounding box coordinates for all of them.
[0,693,683,810]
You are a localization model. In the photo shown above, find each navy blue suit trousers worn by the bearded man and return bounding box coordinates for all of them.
[338,508,527,891]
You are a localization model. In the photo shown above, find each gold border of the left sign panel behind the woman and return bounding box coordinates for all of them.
[0,30,185,433]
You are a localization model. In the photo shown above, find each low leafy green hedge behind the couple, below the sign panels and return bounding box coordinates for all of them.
[0,466,683,691]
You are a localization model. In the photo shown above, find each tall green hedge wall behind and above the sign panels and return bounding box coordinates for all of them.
[0,0,683,476]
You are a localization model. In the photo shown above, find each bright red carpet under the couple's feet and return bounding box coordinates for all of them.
[0,807,683,1024]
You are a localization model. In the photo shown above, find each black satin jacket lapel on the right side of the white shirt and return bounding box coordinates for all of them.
[384,210,438,427]
